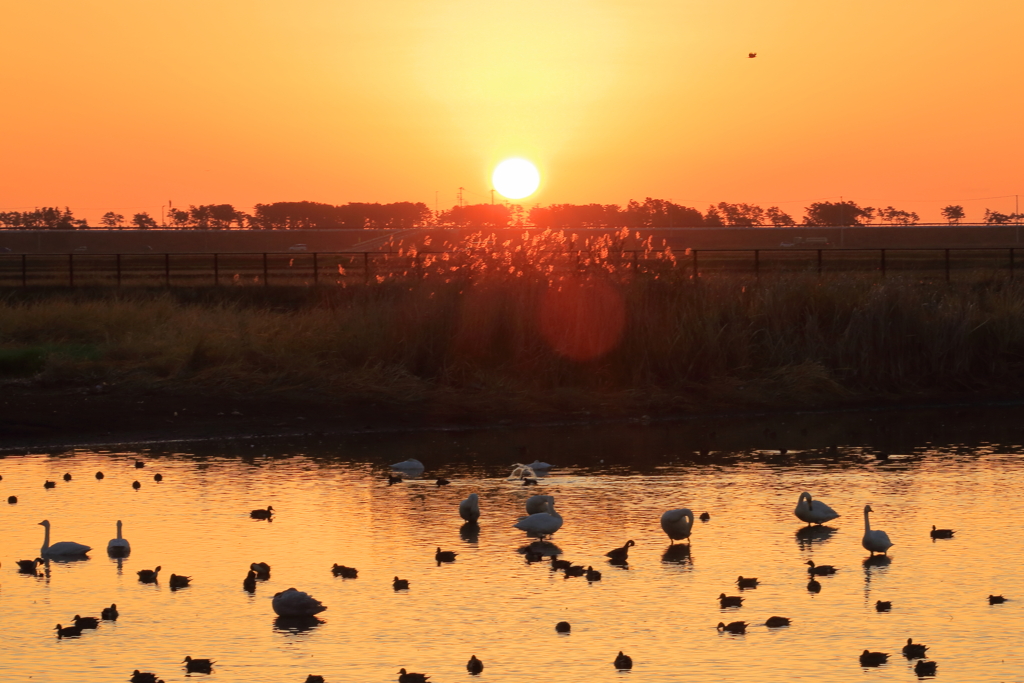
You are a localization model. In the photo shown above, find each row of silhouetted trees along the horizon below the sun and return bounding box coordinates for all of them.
[0,197,1024,230]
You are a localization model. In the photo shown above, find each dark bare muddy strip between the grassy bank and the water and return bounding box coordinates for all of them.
[0,383,1024,456]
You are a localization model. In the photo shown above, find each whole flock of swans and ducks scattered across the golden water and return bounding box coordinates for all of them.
[0,460,1007,683]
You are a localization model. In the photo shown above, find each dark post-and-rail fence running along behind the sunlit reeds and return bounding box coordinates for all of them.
[0,247,1018,287]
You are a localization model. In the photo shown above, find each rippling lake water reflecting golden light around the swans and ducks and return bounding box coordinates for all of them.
[0,409,1024,683]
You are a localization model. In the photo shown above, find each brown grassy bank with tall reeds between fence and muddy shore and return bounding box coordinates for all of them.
[0,264,1024,412]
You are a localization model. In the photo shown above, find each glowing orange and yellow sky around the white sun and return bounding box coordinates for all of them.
[0,0,1024,220]
